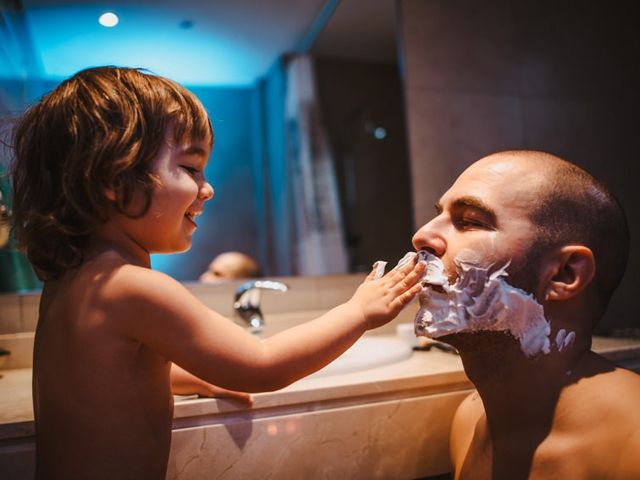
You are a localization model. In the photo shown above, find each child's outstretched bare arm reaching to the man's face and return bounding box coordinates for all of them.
[105,262,424,392]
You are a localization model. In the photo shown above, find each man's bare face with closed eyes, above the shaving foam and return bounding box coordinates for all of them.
[413,155,542,298]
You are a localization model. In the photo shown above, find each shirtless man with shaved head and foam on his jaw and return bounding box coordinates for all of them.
[413,151,640,480]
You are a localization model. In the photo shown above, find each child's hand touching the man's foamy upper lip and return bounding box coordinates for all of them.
[347,261,426,330]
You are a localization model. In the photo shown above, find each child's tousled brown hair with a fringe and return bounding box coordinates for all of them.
[12,67,213,280]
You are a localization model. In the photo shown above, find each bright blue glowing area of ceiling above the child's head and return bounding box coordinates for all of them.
[26,5,273,86]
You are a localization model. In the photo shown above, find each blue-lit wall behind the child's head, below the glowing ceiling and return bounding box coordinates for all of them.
[0,80,260,280]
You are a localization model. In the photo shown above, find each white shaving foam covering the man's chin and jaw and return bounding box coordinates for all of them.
[412,251,551,357]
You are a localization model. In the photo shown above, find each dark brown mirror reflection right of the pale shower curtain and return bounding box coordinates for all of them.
[311,0,413,272]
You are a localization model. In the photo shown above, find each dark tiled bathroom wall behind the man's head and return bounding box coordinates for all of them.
[398,0,640,333]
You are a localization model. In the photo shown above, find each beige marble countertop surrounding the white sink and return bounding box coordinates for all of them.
[0,337,640,440]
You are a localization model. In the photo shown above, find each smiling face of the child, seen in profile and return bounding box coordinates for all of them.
[126,132,213,253]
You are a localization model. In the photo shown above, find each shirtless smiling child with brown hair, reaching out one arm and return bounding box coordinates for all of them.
[8,67,424,479]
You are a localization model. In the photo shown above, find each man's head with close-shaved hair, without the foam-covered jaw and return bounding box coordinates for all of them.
[413,151,629,321]
